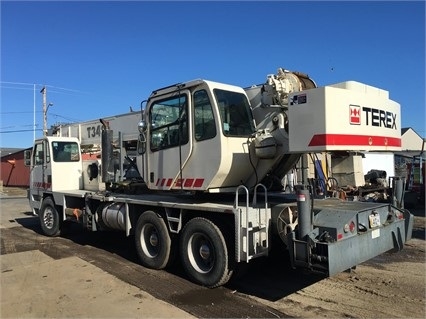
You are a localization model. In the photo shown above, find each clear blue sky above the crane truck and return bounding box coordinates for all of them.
[0,0,426,148]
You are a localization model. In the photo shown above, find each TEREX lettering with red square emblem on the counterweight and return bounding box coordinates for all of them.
[349,104,397,130]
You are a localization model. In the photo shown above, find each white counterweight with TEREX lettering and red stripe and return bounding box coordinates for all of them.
[289,81,401,152]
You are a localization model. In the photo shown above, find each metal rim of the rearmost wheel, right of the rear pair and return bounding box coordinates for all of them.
[188,233,215,274]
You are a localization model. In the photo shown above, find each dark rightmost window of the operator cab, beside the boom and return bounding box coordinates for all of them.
[213,89,255,137]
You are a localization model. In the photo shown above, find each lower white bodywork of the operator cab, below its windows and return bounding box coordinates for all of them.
[147,135,252,192]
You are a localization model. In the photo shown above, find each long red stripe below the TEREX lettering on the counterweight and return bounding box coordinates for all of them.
[309,134,401,147]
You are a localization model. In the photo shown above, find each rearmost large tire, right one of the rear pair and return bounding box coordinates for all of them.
[180,217,232,288]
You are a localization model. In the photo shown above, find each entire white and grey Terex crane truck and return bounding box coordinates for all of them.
[26,68,413,288]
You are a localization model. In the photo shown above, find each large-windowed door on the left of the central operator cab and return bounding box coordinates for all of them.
[147,90,192,189]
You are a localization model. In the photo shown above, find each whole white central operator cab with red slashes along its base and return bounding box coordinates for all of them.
[140,80,255,192]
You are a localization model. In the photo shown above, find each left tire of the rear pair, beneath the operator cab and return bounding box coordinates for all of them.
[135,211,171,269]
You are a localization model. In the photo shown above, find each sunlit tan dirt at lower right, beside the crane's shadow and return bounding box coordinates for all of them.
[241,208,426,318]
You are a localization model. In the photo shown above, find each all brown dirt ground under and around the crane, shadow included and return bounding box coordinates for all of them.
[2,188,426,318]
